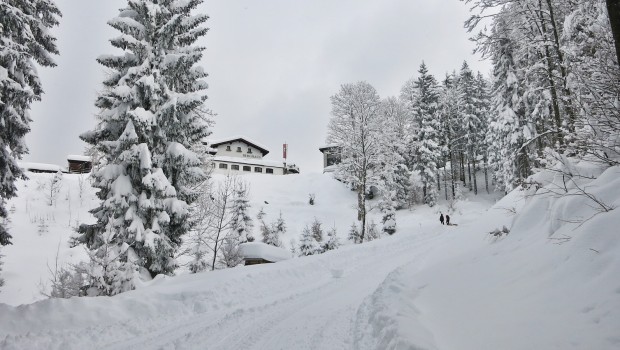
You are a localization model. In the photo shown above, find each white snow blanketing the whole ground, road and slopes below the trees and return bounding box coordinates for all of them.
[0,167,620,350]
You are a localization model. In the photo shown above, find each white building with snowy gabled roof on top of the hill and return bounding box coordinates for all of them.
[206,136,299,175]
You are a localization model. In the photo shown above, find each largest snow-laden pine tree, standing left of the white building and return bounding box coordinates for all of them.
[77,0,210,294]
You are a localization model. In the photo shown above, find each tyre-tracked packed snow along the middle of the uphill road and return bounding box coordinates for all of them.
[117,230,437,350]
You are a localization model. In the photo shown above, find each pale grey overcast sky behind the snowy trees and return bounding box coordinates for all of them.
[24,0,490,172]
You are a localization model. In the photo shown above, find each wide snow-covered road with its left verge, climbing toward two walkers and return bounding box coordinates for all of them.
[0,226,441,350]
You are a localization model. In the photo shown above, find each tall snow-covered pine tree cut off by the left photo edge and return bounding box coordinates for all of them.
[0,0,61,245]
